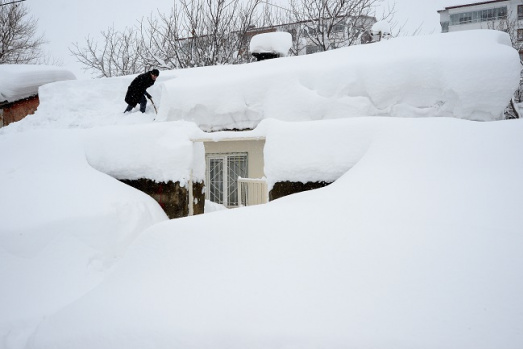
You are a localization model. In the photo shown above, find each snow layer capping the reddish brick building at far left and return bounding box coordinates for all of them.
[0,64,76,102]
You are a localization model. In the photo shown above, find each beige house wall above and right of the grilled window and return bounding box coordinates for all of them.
[204,139,265,178]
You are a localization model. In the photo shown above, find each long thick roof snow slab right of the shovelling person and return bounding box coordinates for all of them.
[157,30,520,130]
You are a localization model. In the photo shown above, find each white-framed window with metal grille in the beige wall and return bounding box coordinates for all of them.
[205,153,248,207]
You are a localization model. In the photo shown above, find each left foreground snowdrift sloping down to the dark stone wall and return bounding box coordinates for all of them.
[0,130,167,328]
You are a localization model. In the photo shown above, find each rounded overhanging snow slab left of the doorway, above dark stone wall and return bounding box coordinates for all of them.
[85,122,205,186]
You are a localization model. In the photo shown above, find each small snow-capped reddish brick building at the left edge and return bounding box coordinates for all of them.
[0,64,76,127]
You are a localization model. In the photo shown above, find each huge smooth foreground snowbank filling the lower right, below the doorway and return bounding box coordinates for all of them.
[31,119,523,349]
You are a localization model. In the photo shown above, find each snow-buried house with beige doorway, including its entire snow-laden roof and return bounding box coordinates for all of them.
[0,30,520,218]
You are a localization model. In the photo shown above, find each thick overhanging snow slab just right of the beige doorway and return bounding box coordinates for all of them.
[257,118,391,188]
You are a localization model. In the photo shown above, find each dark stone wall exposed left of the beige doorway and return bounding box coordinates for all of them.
[121,178,205,219]
